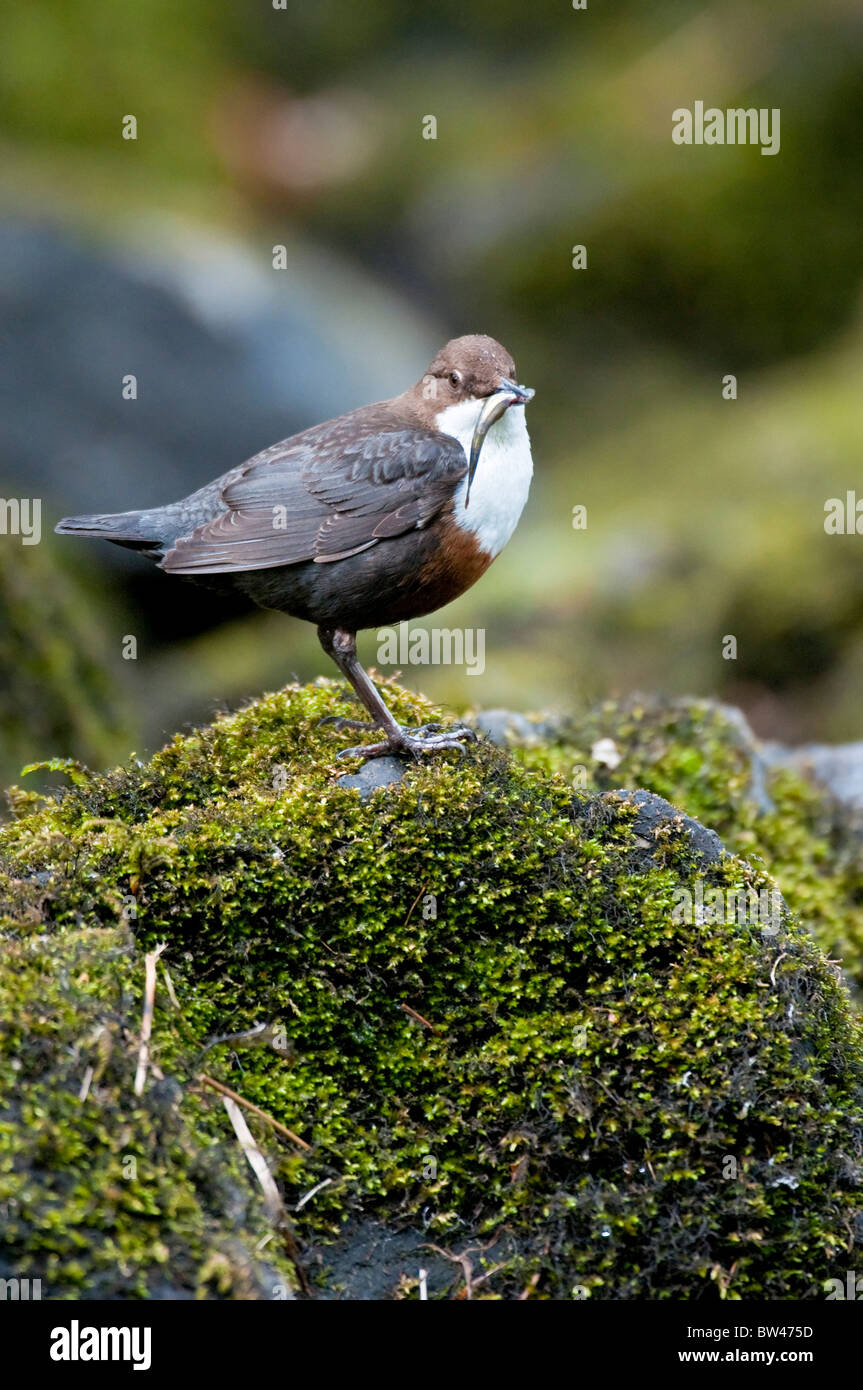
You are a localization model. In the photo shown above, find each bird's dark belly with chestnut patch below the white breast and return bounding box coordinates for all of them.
[233,514,492,632]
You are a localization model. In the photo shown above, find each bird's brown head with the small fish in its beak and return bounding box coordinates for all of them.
[414,334,534,506]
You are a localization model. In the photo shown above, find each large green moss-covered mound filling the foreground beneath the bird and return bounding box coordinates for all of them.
[0,681,863,1298]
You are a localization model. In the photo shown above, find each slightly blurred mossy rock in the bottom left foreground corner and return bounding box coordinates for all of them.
[0,922,289,1298]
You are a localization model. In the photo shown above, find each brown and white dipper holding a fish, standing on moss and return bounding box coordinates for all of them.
[56,334,534,759]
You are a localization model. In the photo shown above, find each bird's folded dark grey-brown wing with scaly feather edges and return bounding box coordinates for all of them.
[163,428,467,574]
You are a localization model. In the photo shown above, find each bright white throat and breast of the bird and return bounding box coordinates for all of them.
[435,399,534,556]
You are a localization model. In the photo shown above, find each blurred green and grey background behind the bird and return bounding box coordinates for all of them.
[0,0,863,780]
